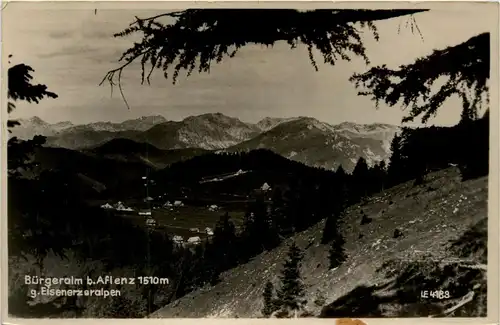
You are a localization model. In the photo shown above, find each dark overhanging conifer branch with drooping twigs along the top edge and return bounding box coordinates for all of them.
[101,9,426,106]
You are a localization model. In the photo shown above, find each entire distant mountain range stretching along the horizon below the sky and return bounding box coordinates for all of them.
[12,113,399,171]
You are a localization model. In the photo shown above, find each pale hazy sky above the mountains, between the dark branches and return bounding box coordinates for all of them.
[2,2,498,125]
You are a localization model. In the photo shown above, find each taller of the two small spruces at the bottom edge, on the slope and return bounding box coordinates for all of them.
[278,243,306,317]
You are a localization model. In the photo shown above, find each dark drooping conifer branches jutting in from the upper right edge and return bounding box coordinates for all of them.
[351,33,490,123]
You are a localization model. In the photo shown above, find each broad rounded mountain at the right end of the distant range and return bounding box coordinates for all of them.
[229,117,398,171]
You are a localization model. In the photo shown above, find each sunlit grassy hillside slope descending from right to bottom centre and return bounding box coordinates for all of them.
[150,169,488,318]
